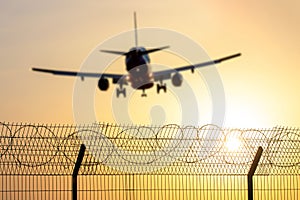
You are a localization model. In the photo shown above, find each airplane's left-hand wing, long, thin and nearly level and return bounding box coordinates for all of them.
[32,67,126,83]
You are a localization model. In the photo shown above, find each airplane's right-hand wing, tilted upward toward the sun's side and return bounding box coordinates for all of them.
[153,53,241,81]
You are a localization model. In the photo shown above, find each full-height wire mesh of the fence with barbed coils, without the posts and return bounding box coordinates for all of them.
[0,123,300,199]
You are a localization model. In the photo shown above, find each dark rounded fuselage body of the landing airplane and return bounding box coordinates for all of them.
[126,47,154,90]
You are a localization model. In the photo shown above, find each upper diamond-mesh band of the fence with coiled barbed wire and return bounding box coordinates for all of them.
[0,123,300,175]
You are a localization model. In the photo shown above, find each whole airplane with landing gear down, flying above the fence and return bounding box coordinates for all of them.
[32,12,241,97]
